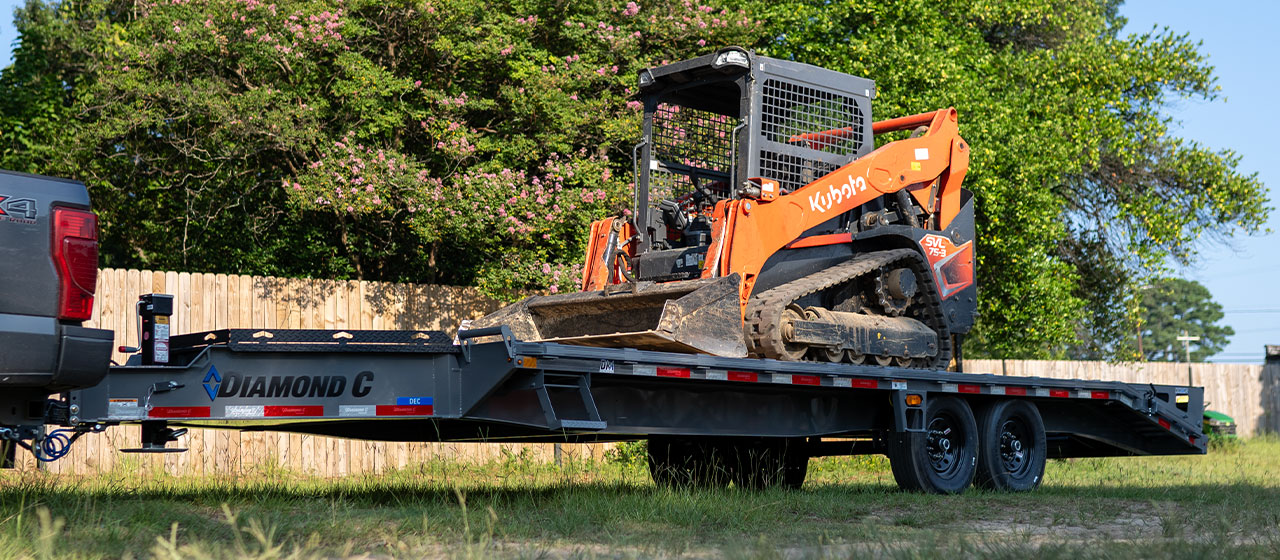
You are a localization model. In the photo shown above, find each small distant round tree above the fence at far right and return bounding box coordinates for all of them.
[1138,277,1235,362]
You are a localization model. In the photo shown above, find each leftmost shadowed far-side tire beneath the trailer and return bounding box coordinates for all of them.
[648,437,730,487]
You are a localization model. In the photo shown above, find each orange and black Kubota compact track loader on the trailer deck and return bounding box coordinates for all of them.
[472,47,977,367]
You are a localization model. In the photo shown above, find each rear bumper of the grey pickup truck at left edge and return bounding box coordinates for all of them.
[0,313,114,393]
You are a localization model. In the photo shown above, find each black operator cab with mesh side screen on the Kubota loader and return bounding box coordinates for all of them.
[634,47,876,281]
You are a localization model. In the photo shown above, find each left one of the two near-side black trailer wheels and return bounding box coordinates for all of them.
[888,396,978,494]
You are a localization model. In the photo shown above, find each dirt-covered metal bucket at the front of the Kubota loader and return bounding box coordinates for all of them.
[471,274,746,358]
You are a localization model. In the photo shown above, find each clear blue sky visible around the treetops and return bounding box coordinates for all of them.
[0,0,1280,362]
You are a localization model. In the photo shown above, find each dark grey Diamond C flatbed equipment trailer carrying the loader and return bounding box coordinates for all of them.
[57,306,1206,492]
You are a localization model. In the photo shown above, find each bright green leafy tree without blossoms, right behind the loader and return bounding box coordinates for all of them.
[751,0,1268,358]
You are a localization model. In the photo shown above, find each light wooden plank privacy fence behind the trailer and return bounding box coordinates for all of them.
[12,268,1280,477]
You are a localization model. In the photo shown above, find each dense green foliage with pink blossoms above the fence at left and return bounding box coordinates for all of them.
[0,0,759,294]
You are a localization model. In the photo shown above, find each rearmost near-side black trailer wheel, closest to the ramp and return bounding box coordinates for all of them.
[975,400,1046,492]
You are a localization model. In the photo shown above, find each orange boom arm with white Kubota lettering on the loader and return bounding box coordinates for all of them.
[703,109,969,306]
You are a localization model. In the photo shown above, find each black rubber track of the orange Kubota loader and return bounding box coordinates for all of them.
[745,249,951,369]
